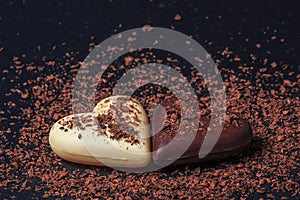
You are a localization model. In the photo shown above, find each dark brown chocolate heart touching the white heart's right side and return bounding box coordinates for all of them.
[152,117,252,165]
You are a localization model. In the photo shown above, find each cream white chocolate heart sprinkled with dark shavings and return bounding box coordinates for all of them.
[49,96,151,168]
